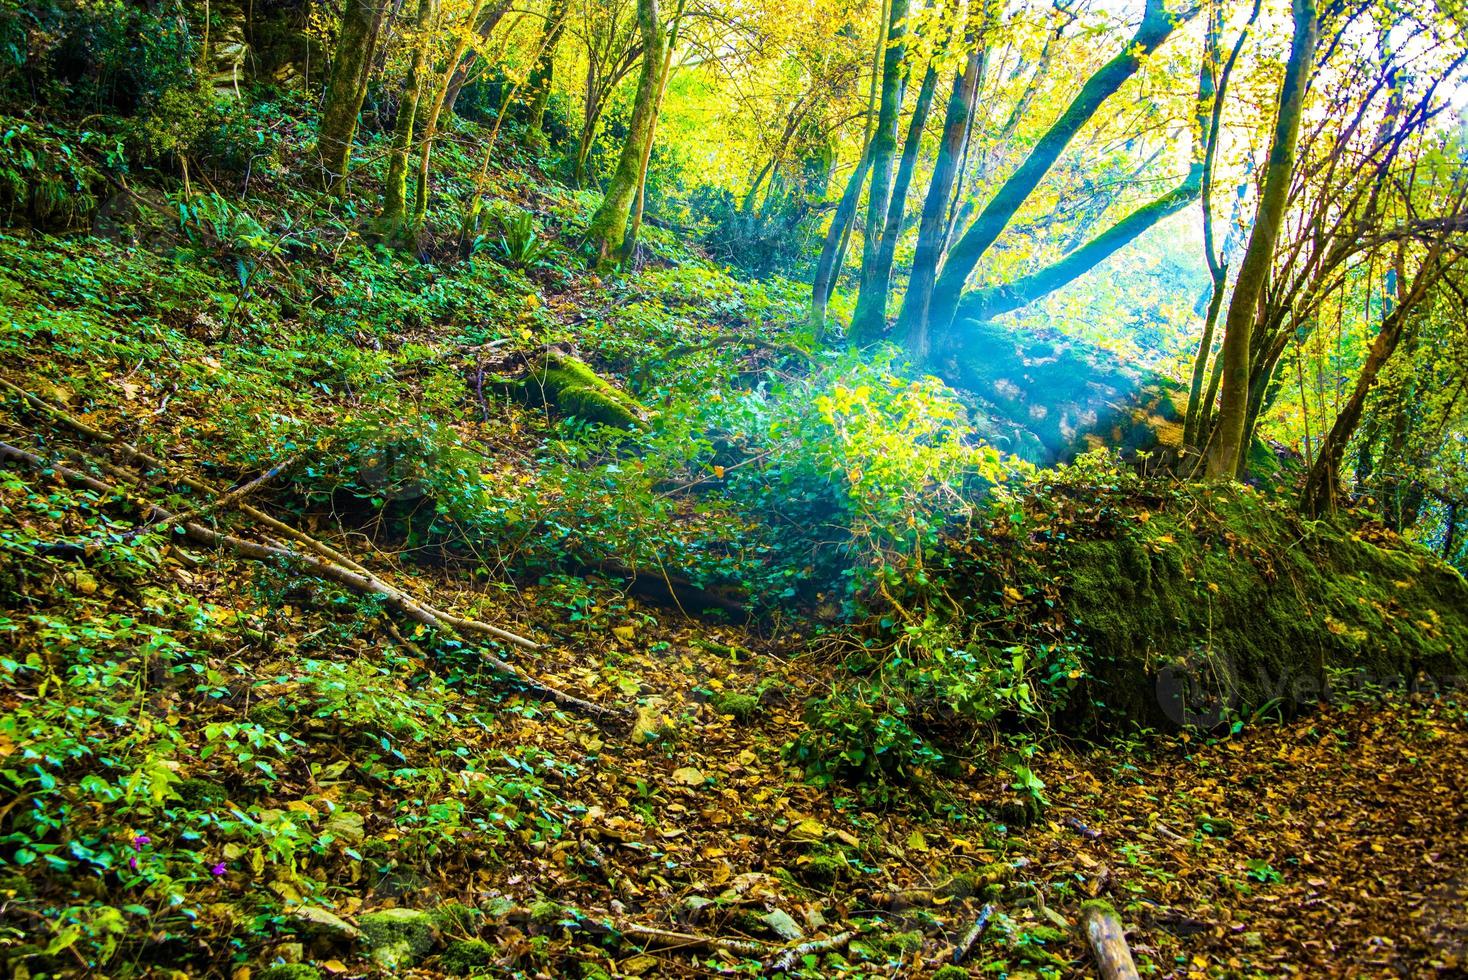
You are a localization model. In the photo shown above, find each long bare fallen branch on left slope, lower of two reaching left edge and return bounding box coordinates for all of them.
[0,443,627,720]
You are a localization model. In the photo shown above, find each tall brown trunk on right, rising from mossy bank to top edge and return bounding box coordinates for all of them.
[1208,0,1318,480]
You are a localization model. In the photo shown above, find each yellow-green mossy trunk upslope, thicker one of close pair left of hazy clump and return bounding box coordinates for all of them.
[587,0,666,268]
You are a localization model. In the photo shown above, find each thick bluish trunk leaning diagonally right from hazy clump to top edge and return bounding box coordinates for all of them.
[929,0,1191,340]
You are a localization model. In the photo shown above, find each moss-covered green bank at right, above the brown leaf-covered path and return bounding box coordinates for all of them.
[1047,487,1468,728]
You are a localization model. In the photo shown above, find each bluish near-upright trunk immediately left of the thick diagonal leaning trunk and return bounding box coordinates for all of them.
[897,40,985,364]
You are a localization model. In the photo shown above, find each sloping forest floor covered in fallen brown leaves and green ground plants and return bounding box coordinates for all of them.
[0,164,1468,980]
